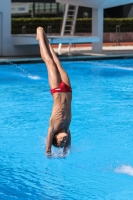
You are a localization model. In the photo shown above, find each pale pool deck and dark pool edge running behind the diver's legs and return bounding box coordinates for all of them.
[0,46,133,64]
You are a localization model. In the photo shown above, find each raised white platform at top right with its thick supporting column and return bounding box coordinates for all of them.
[56,0,133,52]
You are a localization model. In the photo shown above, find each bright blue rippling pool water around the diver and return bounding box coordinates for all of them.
[0,59,133,200]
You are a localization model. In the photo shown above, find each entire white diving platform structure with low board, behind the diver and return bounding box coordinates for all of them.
[0,0,133,56]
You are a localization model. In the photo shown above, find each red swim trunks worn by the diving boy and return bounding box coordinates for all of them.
[50,82,72,94]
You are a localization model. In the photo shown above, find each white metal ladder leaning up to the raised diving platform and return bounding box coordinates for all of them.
[58,4,78,53]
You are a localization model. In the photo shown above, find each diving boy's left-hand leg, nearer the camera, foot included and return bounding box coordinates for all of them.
[36,27,61,89]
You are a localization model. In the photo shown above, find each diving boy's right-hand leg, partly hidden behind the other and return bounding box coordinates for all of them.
[44,29,71,86]
